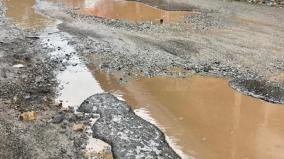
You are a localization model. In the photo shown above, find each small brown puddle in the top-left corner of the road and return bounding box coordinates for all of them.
[3,0,53,29]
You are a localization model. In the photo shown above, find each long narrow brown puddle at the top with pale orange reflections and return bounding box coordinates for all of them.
[51,0,192,23]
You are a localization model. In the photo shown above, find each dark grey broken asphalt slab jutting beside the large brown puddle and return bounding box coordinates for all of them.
[79,94,180,159]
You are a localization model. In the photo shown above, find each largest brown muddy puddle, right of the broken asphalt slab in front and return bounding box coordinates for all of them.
[89,66,284,159]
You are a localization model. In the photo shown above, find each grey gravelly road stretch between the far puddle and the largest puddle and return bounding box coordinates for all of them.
[45,1,284,103]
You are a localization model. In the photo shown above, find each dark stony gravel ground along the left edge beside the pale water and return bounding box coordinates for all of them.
[0,2,92,159]
